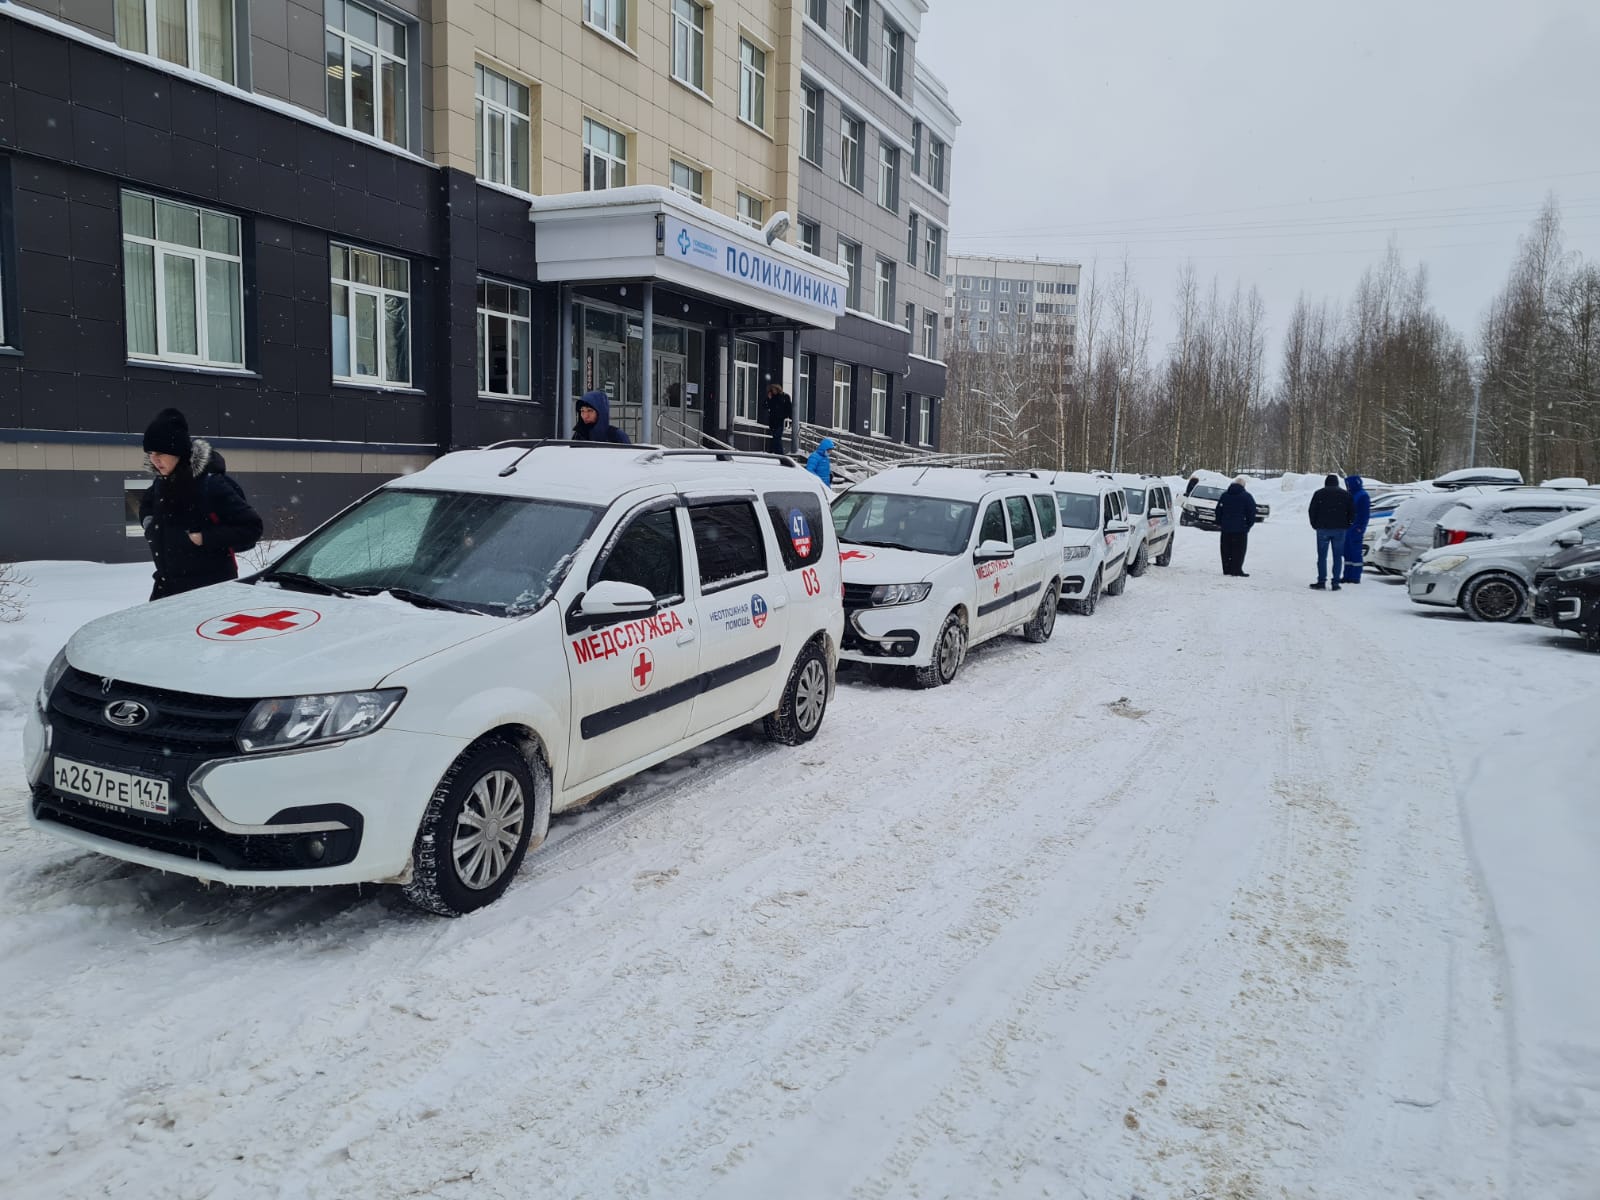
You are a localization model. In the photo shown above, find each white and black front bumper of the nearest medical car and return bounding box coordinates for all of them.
[24,715,466,886]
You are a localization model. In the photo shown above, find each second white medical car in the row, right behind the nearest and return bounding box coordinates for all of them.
[834,467,1061,688]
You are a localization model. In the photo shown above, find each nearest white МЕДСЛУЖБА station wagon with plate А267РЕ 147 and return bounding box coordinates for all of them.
[24,443,843,915]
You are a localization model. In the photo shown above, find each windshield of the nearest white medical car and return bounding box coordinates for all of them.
[262,488,603,616]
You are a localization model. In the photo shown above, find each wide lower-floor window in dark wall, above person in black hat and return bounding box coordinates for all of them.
[122,192,245,366]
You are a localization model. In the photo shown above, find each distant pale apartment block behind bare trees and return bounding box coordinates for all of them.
[944,254,1083,363]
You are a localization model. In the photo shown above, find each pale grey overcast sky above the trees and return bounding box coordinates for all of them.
[917,0,1600,361]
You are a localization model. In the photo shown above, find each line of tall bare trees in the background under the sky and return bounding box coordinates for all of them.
[941,198,1600,480]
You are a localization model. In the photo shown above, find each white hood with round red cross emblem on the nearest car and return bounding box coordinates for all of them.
[67,582,506,698]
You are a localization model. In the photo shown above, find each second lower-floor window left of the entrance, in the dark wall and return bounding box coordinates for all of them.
[328,242,411,384]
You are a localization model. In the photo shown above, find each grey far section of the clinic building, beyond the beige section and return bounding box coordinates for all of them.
[795,0,958,445]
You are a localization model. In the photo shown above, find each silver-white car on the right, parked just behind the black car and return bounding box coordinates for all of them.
[1406,507,1600,621]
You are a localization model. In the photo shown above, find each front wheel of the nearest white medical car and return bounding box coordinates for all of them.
[403,738,550,917]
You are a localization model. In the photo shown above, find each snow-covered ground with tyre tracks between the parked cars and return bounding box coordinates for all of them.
[0,480,1600,1200]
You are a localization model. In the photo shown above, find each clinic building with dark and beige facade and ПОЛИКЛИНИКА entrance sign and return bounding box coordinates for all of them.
[0,0,934,560]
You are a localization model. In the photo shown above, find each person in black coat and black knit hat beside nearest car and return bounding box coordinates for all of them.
[139,408,261,600]
